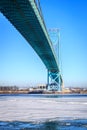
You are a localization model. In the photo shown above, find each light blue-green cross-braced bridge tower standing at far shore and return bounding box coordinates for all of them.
[47,28,62,91]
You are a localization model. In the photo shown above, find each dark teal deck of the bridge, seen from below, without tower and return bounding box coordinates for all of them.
[0,0,58,71]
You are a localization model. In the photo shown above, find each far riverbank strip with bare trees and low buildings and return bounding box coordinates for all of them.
[0,86,87,94]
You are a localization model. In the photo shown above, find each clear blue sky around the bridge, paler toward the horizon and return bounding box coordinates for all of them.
[0,0,87,87]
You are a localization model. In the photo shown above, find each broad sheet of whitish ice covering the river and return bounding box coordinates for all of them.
[0,95,87,130]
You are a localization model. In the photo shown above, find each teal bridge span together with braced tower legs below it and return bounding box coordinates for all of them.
[0,0,63,90]
